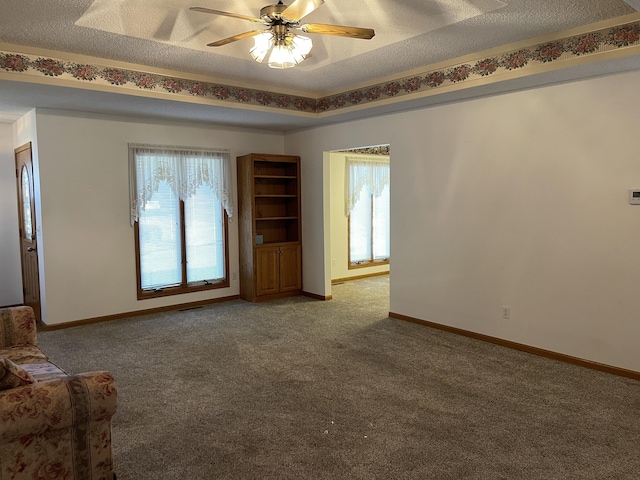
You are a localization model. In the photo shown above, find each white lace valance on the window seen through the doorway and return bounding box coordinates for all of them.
[344,155,390,215]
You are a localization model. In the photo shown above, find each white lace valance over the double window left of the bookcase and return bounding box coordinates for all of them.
[129,144,233,225]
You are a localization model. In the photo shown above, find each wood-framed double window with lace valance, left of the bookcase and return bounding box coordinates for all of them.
[129,145,232,299]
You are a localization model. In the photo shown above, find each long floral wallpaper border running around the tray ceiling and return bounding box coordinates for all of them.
[0,21,640,114]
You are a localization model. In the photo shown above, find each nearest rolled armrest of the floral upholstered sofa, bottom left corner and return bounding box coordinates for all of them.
[0,372,117,480]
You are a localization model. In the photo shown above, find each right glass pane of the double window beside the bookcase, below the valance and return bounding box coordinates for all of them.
[184,185,225,283]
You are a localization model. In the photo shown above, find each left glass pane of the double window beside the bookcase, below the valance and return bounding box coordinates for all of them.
[138,181,182,290]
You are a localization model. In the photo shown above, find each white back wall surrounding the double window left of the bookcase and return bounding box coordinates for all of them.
[21,110,283,325]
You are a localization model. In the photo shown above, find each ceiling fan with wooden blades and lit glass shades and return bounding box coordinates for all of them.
[189,0,375,68]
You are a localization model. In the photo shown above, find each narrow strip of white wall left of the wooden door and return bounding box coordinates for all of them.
[0,123,22,306]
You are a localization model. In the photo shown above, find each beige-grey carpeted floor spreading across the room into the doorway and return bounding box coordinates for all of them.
[39,277,640,480]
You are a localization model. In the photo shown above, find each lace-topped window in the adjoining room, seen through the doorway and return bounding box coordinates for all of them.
[346,157,390,268]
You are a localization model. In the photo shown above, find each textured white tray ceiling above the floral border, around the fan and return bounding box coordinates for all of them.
[0,0,640,129]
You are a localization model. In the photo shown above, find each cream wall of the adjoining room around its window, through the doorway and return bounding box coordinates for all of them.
[329,152,389,280]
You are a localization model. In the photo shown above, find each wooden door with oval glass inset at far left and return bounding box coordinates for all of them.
[15,143,41,320]
